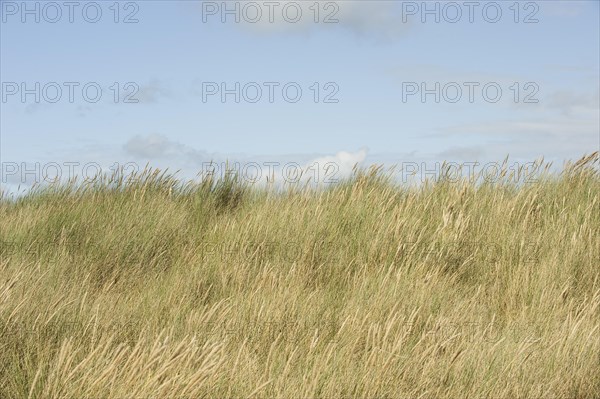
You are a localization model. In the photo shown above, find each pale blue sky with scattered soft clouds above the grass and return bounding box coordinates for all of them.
[0,0,600,191]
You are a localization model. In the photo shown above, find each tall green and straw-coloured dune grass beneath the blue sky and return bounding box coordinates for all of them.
[0,153,600,399]
